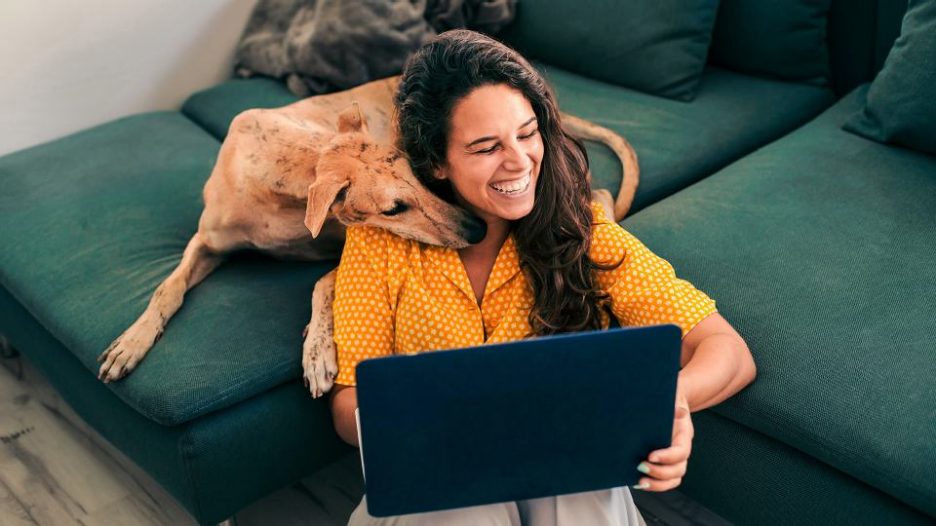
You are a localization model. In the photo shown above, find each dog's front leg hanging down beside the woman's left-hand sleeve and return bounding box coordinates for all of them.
[302,269,338,398]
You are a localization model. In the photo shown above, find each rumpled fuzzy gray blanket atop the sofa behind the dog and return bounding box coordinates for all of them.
[235,0,517,97]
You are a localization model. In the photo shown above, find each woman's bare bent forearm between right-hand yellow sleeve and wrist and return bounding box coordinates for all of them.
[677,312,757,411]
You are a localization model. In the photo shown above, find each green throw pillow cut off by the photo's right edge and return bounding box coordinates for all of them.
[844,0,936,154]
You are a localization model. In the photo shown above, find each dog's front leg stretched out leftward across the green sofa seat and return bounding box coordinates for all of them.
[97,232,223,383]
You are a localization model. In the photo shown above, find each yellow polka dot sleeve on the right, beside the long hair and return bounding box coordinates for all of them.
[589,203,717,337]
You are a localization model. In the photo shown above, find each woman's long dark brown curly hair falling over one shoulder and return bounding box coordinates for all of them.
[395,30,621,336]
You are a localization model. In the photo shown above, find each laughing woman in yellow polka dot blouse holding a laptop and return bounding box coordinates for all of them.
[329,30,755,526]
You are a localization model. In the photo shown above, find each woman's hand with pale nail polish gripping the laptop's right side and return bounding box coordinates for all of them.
[634,389,695,491]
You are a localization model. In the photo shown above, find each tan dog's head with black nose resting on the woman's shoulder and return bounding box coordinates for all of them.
[305,103,487,252]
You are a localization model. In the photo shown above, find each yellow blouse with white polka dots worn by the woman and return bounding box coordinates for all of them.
[334,202,715,385]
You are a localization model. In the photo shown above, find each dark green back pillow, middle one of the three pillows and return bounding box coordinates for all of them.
[711,0,831,86]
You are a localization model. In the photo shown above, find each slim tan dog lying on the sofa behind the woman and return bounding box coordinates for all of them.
[98,72,639,397]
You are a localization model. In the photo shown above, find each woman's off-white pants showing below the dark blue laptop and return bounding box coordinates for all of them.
[348,486,646,526]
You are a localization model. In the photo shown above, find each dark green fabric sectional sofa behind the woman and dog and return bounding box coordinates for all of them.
[0,0,936,525]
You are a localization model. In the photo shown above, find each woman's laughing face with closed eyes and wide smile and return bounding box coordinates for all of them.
[436,84,543,225]
